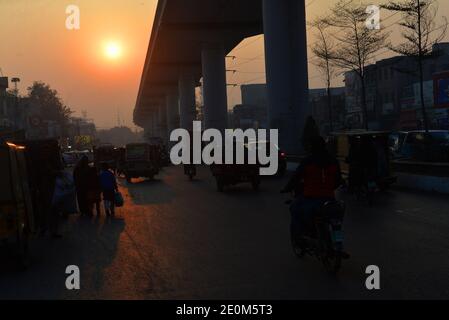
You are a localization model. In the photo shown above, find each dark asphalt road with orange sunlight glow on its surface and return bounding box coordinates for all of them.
[0,167,449,299]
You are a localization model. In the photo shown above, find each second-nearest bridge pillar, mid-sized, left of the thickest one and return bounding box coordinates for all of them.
[201,44,228,131]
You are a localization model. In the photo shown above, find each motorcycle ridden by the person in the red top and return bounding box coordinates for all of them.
[286,196,349,274]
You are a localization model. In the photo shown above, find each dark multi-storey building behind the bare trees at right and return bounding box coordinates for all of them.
[345,43,449,130]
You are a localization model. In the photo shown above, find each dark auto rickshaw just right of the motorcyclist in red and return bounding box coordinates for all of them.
[328,130,397,190]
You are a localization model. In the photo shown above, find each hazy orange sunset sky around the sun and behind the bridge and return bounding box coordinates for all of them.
[0,0,449,128]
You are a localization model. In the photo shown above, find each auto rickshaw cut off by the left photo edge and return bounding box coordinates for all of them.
[0,143,34,266]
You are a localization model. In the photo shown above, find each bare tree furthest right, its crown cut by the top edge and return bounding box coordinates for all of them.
[382,0,448,132]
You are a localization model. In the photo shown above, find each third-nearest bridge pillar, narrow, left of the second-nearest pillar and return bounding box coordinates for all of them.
[178,70,196,130]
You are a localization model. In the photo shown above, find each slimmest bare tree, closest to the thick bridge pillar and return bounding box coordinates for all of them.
[310,17,336,132]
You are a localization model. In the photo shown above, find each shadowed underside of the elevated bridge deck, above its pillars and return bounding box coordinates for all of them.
[134,0,263,127]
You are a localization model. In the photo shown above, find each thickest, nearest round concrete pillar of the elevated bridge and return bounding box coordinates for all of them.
[263,0,310,154]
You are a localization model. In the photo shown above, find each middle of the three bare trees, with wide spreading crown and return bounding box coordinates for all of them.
[325,0,389,129]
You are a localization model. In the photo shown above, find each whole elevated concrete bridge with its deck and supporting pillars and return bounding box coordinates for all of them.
[134,0,308,153]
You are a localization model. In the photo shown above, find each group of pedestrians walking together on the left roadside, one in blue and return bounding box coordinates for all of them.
[73,156,118,216]
